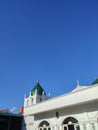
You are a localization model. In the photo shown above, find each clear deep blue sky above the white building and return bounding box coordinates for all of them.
[0,0,98,111]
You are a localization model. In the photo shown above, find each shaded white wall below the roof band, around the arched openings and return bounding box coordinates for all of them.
[25,101,98,130]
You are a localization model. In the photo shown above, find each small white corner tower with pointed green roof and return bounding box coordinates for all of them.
[24,80,49,107]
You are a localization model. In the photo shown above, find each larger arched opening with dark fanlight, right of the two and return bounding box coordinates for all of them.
[62,117,80,130]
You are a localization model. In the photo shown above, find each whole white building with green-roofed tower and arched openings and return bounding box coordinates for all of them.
[23,79,98,130]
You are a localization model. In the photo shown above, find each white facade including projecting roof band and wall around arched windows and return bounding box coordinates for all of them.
[23,85,98,130]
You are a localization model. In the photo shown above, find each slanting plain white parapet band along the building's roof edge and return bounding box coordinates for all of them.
[24,86,98,115]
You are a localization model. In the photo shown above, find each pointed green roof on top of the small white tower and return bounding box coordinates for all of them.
[31,80,45,96]
